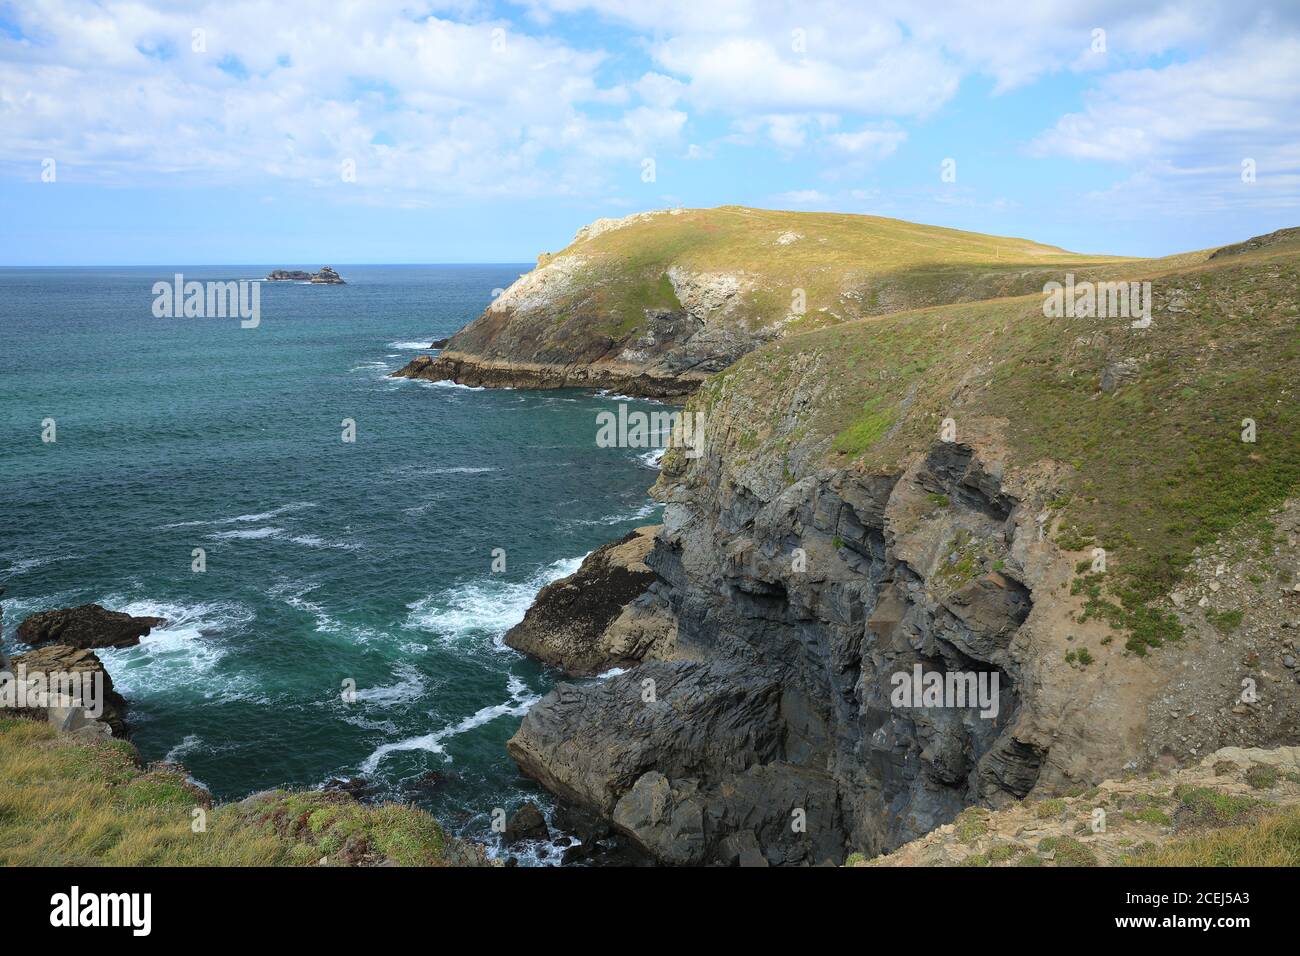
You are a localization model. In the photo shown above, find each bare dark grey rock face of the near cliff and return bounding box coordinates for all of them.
[508,445,1044,865]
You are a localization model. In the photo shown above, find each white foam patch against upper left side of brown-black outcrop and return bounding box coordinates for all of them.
[407,555,586,644]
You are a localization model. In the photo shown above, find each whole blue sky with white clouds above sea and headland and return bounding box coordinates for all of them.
[0,0,1300,265]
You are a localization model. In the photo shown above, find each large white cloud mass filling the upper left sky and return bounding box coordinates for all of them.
[0,0,686,202]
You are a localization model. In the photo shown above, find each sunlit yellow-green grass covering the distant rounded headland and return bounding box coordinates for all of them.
[458,206,1127,359]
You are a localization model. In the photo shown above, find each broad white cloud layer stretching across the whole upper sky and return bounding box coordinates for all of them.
[0,0,1300,217]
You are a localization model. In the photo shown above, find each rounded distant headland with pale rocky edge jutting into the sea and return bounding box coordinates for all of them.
[395,207,1149,398]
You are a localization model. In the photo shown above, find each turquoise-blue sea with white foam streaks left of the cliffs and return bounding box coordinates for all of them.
[0,263,657,863]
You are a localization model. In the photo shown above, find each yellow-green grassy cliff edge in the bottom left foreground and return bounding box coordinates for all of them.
[0,719,473,866]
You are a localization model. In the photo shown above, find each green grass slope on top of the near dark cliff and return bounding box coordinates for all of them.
[681,227,1300,656]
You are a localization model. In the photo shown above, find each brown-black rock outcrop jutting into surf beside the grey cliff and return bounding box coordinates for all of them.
[506,527,666,676]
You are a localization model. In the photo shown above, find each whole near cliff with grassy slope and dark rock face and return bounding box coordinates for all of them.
[508,222,1300,864]
